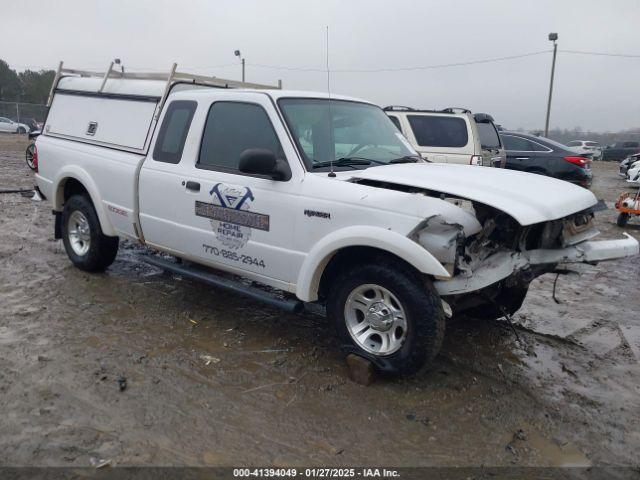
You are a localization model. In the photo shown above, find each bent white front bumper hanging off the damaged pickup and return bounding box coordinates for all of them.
[434,233,640,296]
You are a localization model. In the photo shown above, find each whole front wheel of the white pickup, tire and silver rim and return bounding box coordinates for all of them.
[327,263,445,374]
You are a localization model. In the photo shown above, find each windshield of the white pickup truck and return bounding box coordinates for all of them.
[278,98,418,169]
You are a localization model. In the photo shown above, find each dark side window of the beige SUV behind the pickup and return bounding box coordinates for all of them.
[407,115,469,148]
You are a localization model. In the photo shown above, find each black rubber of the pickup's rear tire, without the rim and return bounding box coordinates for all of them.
[62,195,119,272]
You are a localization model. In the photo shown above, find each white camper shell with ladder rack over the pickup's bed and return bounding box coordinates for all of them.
[45,63,282,153]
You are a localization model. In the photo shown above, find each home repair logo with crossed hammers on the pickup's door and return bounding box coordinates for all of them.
[196,183,269,249]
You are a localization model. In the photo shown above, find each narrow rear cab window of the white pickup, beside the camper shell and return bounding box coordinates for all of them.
[153,100,198,163]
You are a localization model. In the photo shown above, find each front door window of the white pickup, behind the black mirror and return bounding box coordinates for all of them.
[196,102,284,171]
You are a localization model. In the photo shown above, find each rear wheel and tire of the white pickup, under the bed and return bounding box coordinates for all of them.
[62,195,119,272]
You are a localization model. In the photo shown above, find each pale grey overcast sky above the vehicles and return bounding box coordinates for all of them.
[5,0,640,131]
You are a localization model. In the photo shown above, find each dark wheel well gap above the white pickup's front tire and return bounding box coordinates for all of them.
[318,246,424,300]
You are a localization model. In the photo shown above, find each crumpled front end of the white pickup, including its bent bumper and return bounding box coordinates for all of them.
[414,199,638,316]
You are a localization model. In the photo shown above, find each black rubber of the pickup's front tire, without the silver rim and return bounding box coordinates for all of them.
[327,262,445,374]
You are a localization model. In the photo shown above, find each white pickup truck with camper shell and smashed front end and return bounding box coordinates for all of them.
[36,61,638,373]
